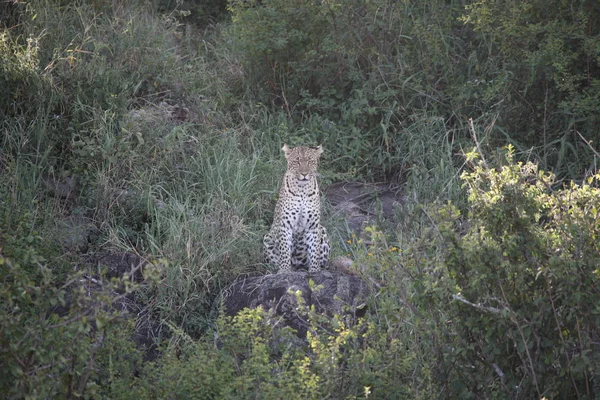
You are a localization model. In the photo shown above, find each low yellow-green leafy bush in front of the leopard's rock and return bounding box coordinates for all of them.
[106,296,431,399]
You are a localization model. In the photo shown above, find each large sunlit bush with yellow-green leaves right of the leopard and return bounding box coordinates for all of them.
[408,148,600,398]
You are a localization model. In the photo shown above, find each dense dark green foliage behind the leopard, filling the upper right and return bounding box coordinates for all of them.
[230,0,600,178]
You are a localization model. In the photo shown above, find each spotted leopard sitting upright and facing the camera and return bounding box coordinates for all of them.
[263,144,329,273]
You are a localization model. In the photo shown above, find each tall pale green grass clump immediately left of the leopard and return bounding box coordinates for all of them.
[136,136,272,334]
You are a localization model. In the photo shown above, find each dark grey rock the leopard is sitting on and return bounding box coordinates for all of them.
[223,271,368,338]
